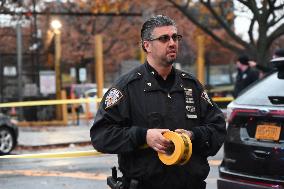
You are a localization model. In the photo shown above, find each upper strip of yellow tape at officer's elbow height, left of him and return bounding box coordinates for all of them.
[0,98,101,108]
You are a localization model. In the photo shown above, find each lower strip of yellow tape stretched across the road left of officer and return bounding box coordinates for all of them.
[0,150,102,159]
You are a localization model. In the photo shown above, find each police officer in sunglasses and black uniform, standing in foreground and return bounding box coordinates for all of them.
[90,15,226,189]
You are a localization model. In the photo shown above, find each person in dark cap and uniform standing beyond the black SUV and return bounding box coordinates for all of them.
[233,55,259,98]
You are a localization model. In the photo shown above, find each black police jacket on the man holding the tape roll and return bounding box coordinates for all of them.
[91,65,226,188]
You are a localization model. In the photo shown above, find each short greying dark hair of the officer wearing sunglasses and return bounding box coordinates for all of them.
[141,15,176,52]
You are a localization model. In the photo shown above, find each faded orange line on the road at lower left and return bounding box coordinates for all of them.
[0,170,108,180]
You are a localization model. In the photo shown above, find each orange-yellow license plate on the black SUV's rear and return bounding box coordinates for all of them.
[255,125,281,141]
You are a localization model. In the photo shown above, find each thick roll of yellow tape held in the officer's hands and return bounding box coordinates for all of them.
[158,131,192,165]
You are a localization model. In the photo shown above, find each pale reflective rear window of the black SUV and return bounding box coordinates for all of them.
[235,73,284,106]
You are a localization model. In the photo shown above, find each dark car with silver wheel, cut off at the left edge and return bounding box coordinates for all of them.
[0,113,18,155]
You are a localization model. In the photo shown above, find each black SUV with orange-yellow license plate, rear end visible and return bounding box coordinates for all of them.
[217,58,284,189]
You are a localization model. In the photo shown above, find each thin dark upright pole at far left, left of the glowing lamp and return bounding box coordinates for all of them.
[16,21,23,120]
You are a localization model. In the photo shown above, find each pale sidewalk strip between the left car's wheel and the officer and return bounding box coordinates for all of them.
[18,120,93,148]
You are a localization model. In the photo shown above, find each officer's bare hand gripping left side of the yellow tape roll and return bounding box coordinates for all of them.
[146,129,172,153]
